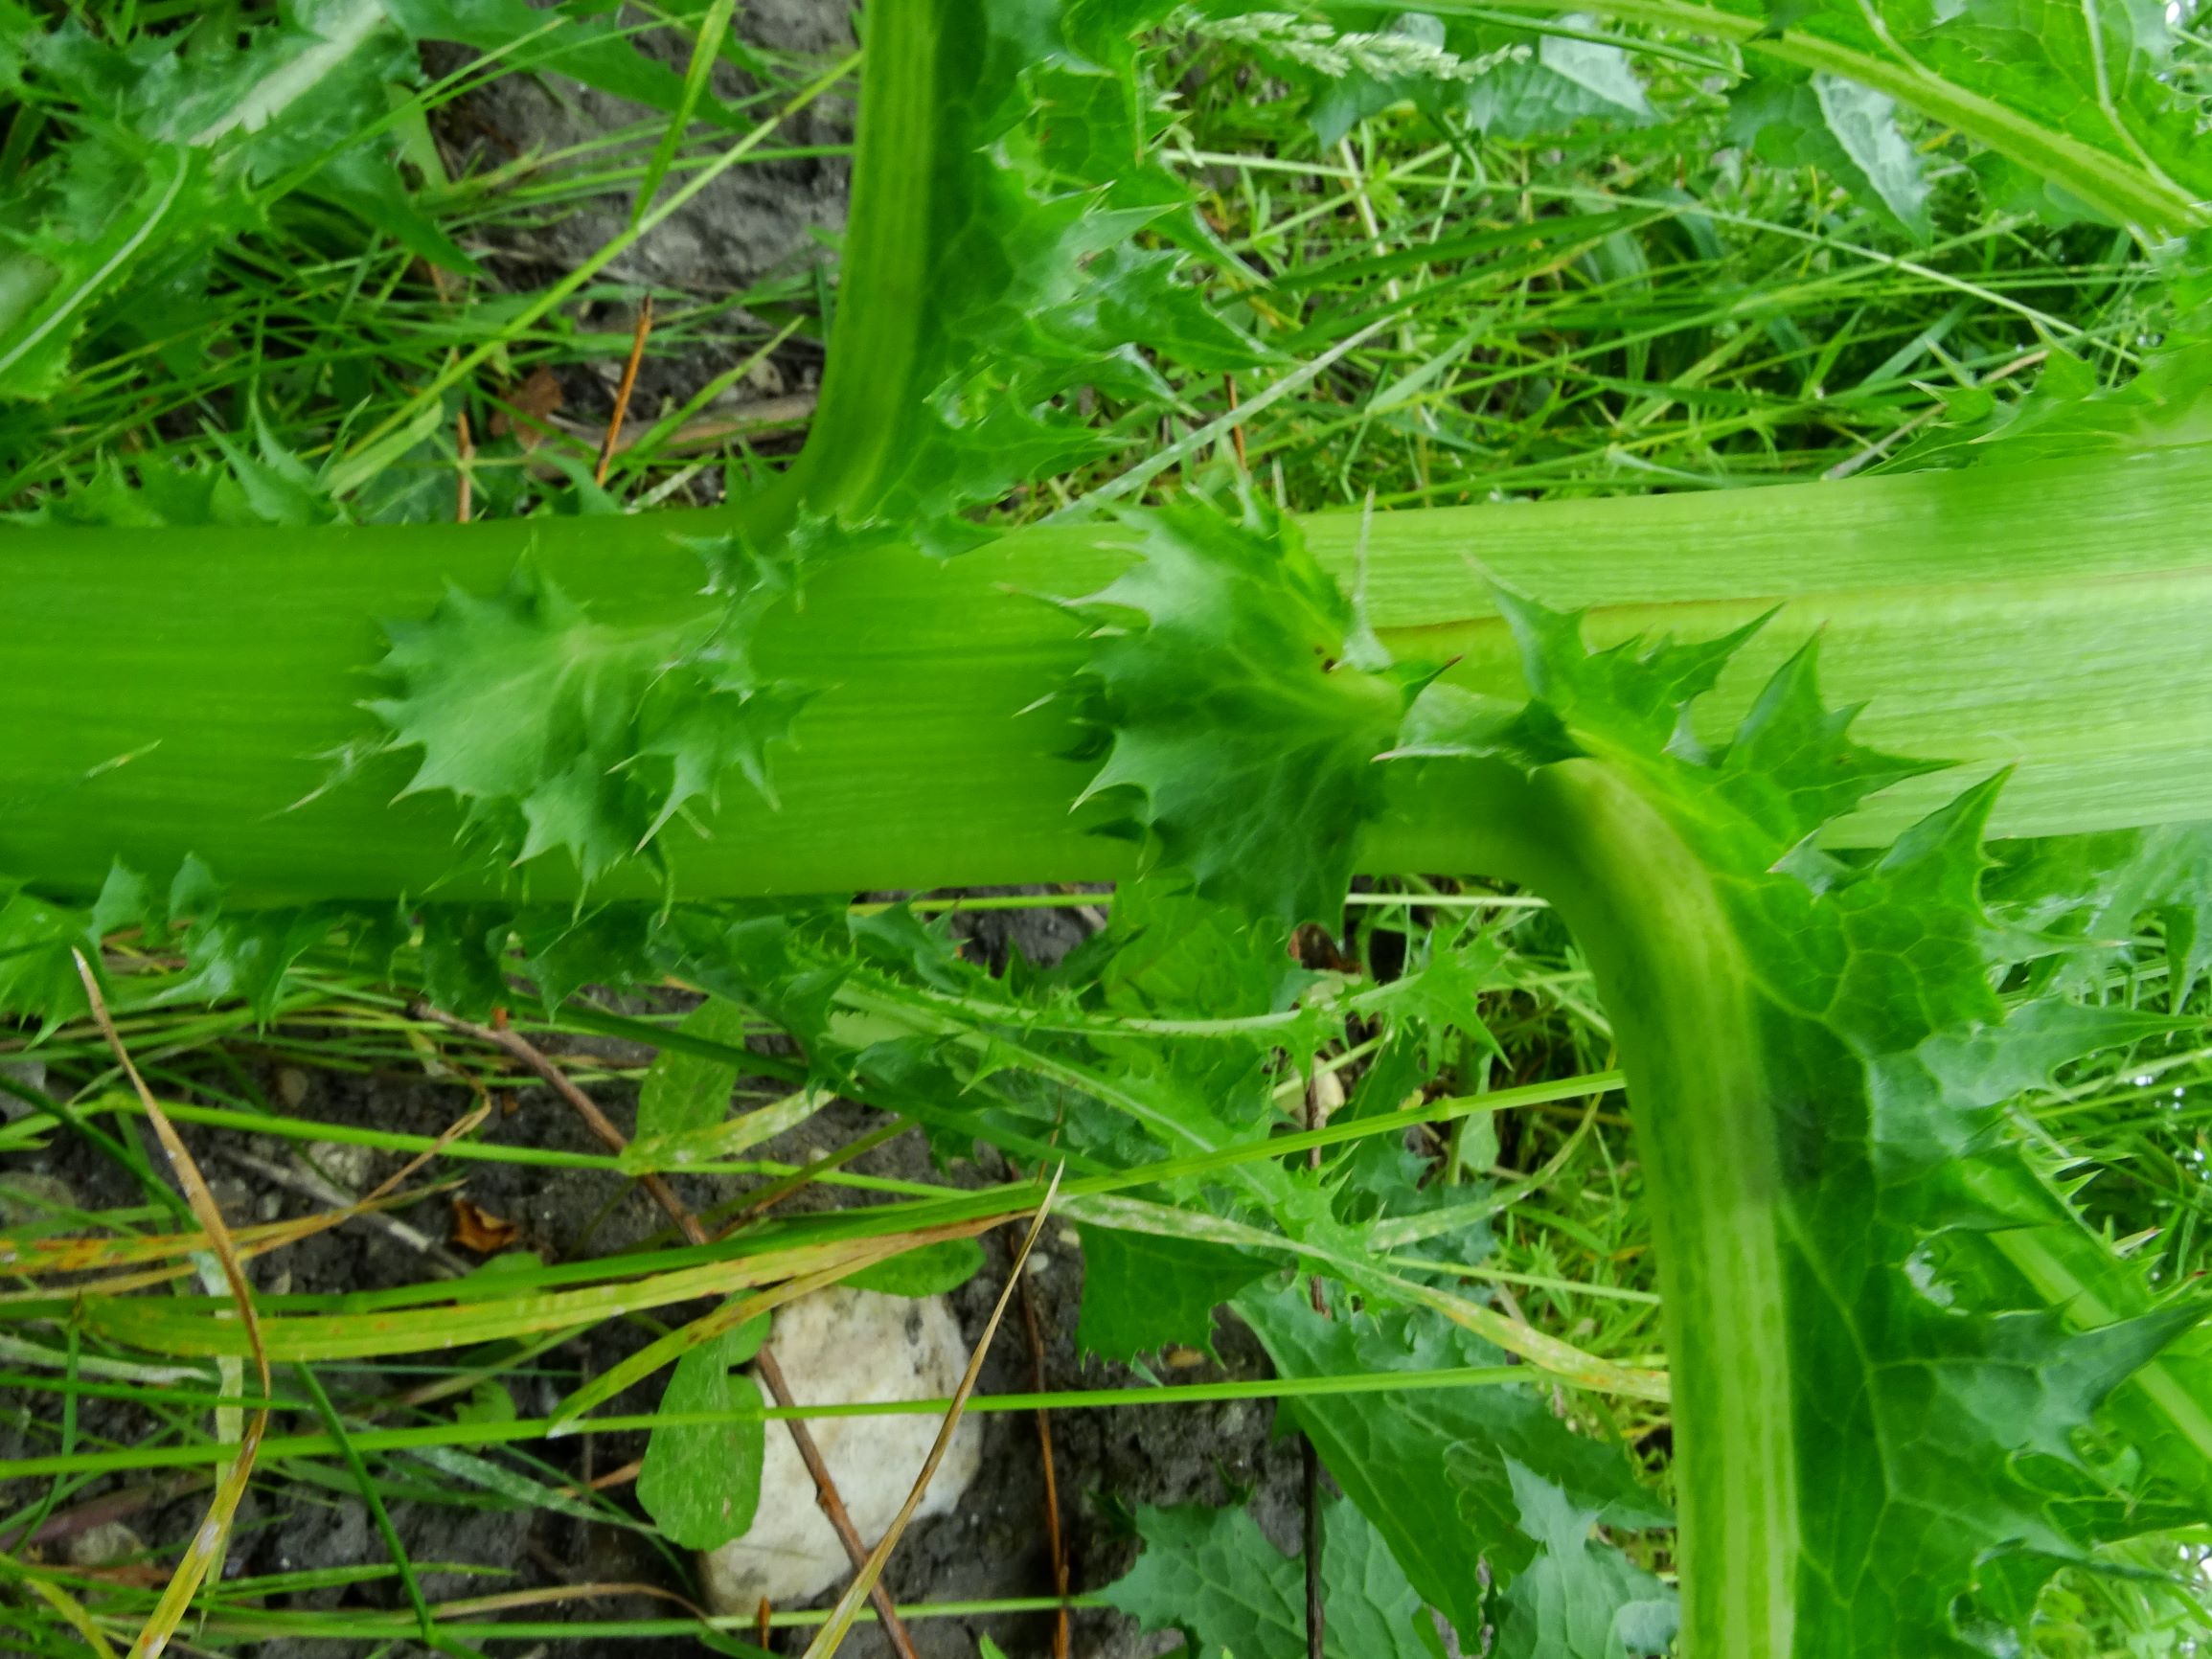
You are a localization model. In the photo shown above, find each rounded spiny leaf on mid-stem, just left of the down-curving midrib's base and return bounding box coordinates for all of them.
[1077,509,1416,922]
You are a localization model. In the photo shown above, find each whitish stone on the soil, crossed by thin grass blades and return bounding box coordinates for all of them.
[701,1289,982,1615]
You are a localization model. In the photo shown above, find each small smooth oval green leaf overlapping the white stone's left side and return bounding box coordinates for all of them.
[637,1314,767,1551]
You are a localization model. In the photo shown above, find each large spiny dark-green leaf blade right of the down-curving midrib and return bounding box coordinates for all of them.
[1380,598,2212,1659]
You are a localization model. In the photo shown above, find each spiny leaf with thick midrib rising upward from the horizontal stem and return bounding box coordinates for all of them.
[752,0,1266,556]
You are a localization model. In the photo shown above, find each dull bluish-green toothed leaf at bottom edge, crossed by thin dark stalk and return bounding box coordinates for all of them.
[1102,1500,1442,1659]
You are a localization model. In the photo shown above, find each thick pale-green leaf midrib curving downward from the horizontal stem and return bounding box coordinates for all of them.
[1469,761,1798,1659]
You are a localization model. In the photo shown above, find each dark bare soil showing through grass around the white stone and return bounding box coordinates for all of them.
[0,911,1301,1659]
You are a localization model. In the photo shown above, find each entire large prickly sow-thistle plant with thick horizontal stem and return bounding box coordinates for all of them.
[0,0,2212,1659]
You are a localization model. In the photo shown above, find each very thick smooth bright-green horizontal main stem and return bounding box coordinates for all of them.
[0,446,2212,902]
